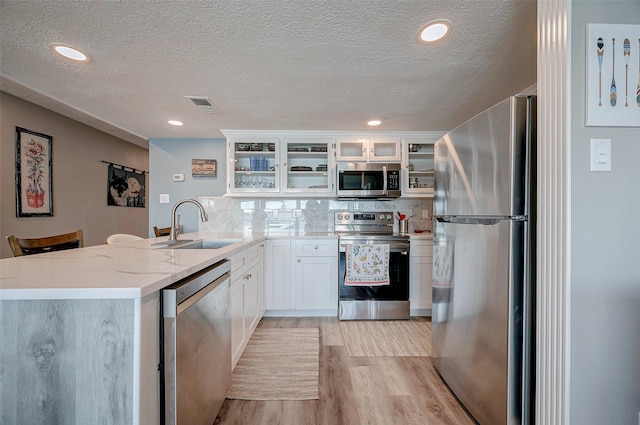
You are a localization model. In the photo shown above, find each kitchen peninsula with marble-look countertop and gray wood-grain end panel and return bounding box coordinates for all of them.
[0,233,265,425]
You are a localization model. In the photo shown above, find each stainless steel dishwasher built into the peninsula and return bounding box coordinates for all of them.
[160,260,231,425]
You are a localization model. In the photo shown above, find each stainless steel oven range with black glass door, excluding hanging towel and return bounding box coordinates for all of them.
[334,211,410,320]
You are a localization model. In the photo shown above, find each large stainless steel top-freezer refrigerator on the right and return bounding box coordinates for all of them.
[432,95,536,425]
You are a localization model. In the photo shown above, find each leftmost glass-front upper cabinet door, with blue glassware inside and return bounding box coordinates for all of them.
[229,138,280,192]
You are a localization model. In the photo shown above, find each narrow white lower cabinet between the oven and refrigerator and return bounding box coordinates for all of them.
[409,239,433,316]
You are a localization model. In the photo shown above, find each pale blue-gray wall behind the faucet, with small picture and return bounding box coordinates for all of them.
[149,139,227,236]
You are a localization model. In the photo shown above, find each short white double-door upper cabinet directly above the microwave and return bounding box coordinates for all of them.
[336,137,402,162]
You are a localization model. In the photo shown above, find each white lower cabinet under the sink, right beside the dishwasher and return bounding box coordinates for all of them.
[230,243,264,368]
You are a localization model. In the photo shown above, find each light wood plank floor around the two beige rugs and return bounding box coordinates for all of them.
[215,317,475,425]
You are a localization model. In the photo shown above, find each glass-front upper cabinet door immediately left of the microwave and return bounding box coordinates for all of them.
[281,138,334,194]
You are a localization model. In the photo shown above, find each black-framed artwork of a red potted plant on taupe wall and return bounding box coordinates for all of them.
[16,127,53,217]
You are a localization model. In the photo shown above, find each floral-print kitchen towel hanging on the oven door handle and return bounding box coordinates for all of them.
[344,244,389,286]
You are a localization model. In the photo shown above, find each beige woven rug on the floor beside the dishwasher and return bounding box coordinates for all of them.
[227,328,320,400]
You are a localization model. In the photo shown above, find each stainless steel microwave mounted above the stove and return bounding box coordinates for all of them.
[336,162,401,199]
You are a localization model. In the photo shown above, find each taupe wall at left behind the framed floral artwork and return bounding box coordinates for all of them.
[0,92,149,258]
